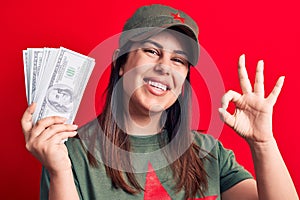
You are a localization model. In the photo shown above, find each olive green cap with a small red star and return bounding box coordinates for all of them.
[120,4,200,66]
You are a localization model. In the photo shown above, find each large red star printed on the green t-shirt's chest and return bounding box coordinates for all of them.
[144,162,218,200]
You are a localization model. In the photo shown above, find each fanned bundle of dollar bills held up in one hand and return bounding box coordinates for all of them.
[23,47,95,124]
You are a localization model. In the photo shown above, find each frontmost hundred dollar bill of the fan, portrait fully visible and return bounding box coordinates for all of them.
[33,47,95,124]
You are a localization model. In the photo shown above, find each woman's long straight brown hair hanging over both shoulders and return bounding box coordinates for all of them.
[88,28,207,199]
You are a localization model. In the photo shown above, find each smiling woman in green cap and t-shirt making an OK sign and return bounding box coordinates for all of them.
[22,5,298,200]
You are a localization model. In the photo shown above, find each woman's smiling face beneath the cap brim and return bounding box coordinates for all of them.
[119,30,189,114]
